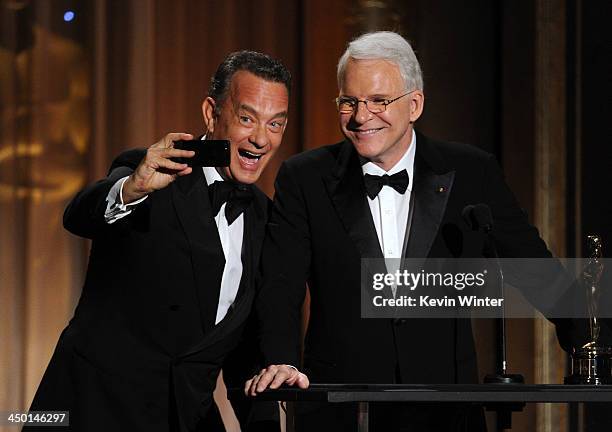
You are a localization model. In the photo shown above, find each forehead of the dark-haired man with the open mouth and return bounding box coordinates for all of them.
[230,71,289,113]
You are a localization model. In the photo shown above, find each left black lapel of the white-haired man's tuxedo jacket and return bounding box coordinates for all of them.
[324,141,383,259]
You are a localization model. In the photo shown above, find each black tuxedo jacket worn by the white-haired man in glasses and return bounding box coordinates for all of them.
[256,133,564,383]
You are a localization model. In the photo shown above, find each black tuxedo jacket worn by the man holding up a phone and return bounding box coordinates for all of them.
[32,151,269,432]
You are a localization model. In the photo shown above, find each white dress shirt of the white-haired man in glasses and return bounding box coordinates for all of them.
[361,130,416,295]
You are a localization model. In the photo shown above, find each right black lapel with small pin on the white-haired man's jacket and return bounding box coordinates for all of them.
[405,134,455,258]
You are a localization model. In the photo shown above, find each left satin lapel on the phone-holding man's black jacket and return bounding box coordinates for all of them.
[172,169,225,333]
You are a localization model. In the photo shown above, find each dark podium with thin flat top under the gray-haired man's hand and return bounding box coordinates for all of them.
[228,384,612,432]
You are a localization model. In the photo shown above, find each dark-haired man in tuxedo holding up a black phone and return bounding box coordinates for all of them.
[26,51,291,431]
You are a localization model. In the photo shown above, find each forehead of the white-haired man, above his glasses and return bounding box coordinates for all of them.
[340,59,405,97]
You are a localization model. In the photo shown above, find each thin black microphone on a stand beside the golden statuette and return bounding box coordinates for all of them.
[461,203,525,384]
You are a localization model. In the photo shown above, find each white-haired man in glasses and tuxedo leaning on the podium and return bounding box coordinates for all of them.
[245,32,550,432]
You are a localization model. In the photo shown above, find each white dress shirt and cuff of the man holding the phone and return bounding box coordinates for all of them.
[104,167,244,324]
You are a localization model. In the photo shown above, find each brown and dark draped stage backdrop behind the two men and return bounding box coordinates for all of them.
[0,0,612,431]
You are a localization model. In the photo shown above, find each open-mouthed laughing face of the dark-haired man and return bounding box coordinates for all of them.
[202,71,289,184]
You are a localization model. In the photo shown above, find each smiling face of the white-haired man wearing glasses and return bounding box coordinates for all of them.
[339,58,424,171]
